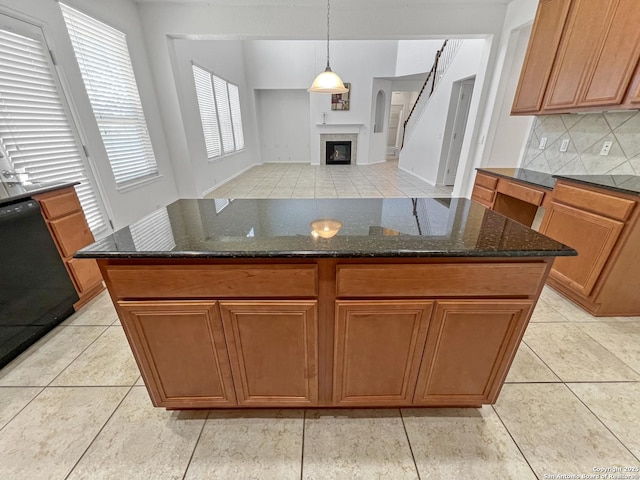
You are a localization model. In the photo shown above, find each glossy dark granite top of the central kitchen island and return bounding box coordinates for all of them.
[75,198,576,258]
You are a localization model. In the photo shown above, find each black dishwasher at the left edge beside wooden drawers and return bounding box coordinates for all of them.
[0,200,78,368]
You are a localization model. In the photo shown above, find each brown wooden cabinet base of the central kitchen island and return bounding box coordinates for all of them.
[100,258,550,408]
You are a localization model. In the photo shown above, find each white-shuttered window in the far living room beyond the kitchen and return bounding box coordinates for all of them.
[192,65,244,159]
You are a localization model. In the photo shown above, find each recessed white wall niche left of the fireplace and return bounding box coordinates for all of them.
[255,89,310,163]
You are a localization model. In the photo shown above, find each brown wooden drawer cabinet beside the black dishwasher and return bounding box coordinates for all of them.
[33,187,104,310]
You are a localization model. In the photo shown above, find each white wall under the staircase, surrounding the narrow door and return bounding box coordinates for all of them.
[398,40,487,185]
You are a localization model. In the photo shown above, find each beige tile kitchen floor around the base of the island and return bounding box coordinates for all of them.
[0,165,640,480]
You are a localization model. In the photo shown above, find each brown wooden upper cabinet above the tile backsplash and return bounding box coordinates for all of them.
[512,0,640,114]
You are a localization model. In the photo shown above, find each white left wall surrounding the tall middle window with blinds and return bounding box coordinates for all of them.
[0,0,177,232]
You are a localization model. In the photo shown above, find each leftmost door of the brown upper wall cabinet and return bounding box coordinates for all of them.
[511,0,571,114]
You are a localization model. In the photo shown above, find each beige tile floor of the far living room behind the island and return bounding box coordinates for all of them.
[206,161,452,198]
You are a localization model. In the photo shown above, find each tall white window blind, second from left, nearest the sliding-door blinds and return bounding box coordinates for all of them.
[60,3,158,187]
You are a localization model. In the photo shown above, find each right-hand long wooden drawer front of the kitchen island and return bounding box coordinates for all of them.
[337,263,546,297]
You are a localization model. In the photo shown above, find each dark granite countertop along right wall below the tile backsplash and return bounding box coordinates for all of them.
[476,167,640,195]
